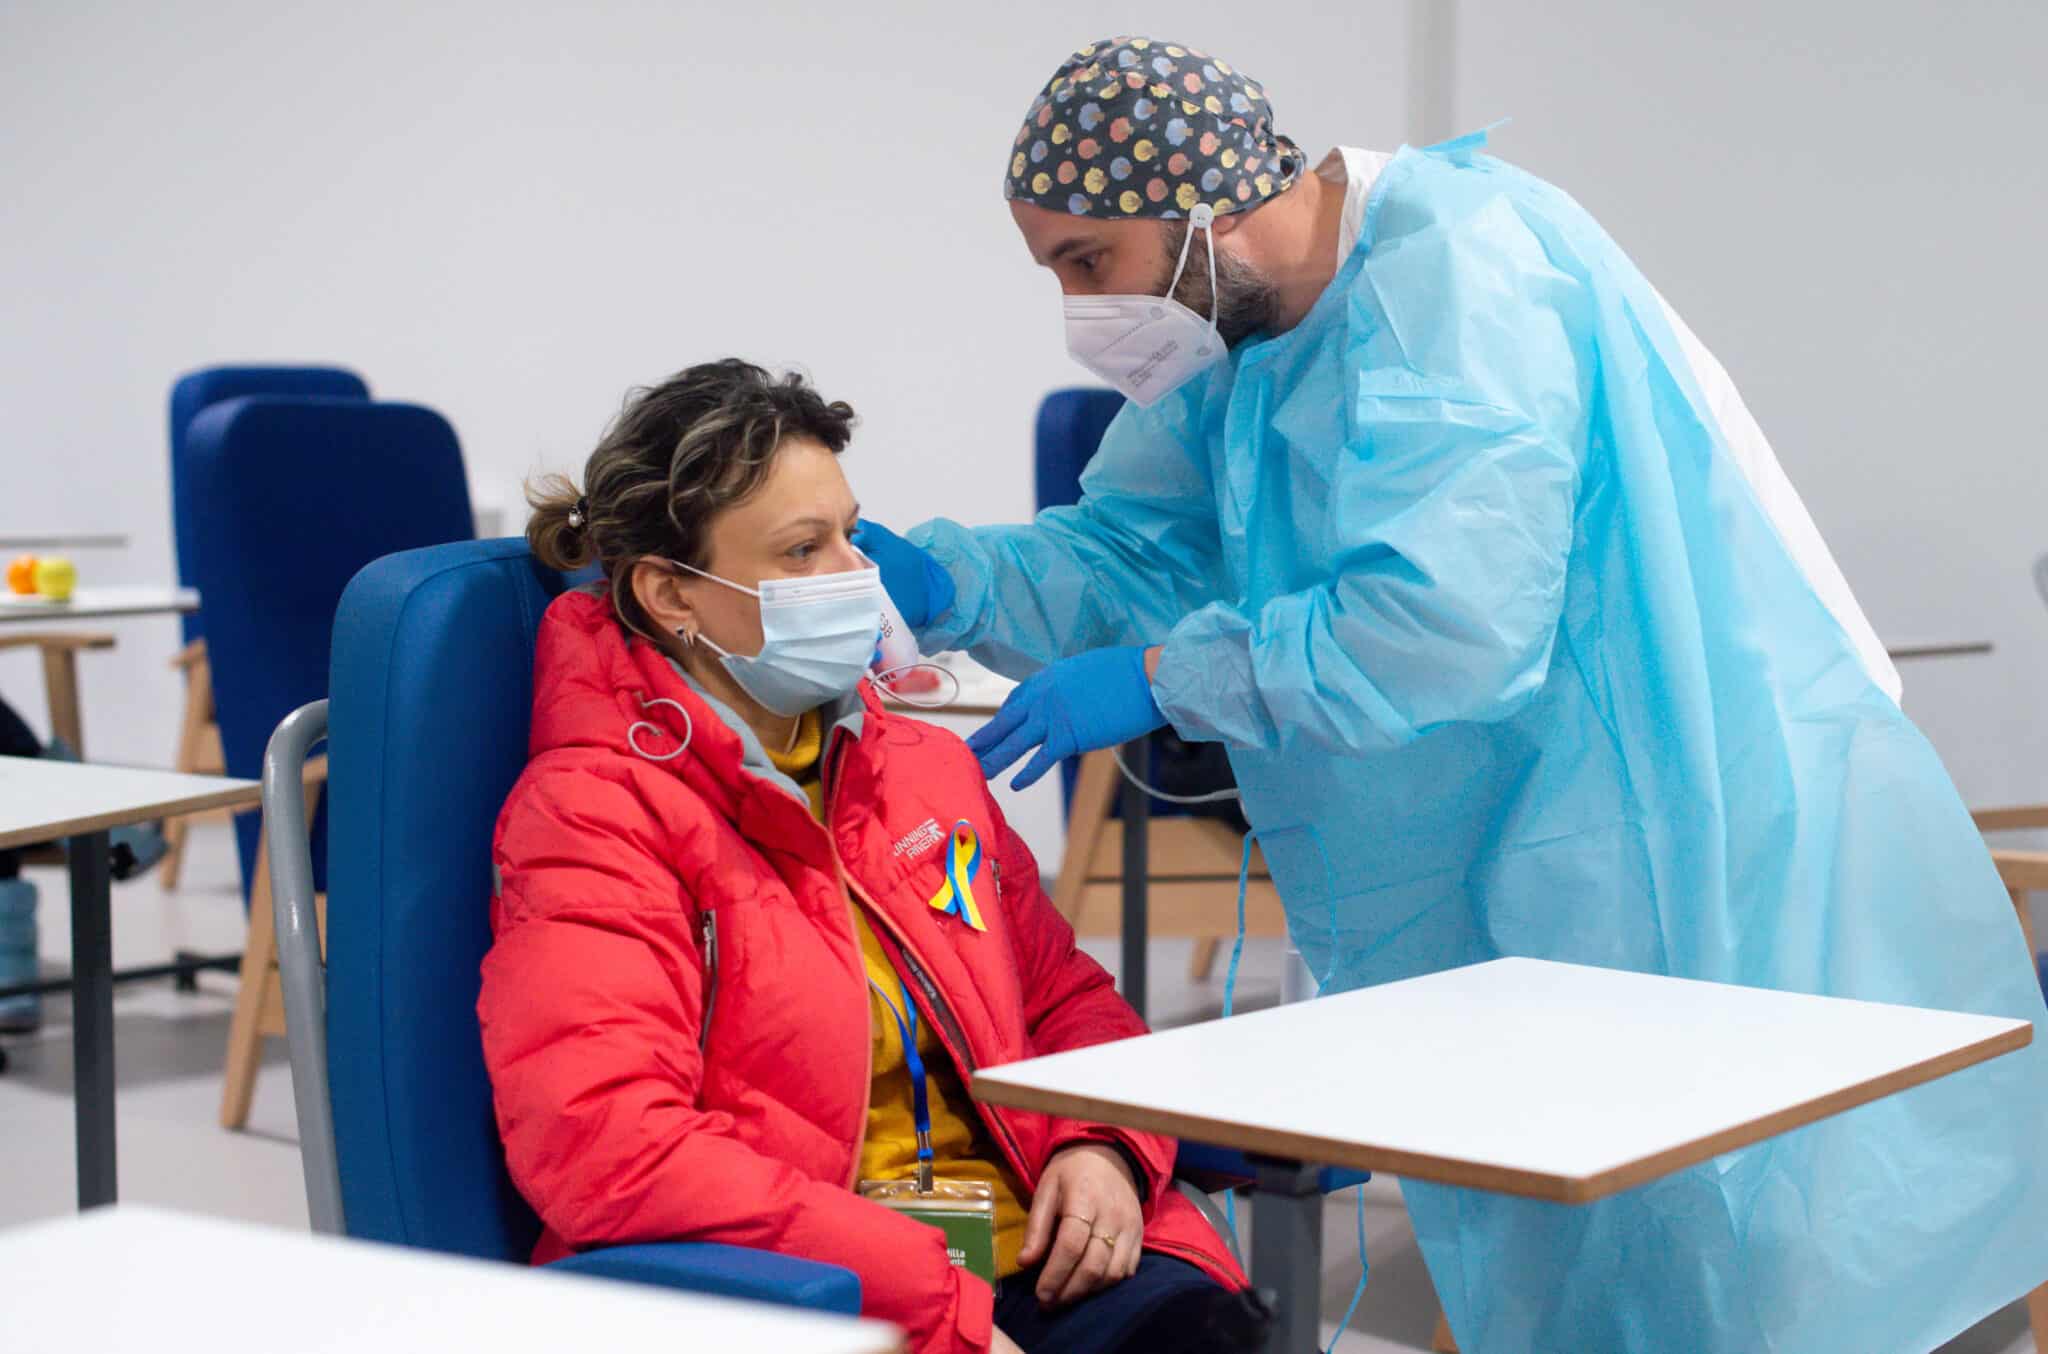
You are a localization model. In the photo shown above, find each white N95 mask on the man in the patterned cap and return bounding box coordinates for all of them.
[1067,203,1225,410]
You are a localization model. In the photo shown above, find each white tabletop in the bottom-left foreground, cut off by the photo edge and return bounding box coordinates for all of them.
[0,1204,901,1354]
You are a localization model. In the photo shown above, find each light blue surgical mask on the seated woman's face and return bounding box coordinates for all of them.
[672,559,883,717]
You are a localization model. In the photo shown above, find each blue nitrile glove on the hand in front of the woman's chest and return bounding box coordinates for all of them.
[967,645,1165,791]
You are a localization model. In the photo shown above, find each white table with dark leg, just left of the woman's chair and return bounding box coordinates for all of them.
[0,758,262,1212]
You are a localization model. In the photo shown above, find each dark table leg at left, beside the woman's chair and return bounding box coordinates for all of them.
[66,832,117,1209]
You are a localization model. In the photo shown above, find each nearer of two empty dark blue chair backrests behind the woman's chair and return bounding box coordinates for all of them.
[184,395,475,891]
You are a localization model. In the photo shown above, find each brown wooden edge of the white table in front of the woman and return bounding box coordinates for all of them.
[969,1022,2034,1204]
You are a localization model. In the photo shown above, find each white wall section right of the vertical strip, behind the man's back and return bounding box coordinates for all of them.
[1450,0,2048,819]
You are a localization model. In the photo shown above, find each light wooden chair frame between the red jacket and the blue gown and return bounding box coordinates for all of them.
[1053,750,1286,966]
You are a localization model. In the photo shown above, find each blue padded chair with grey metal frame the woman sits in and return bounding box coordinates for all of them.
[264,541,860,1313]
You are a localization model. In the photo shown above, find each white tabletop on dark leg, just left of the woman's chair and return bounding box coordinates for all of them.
[0,758,262,846]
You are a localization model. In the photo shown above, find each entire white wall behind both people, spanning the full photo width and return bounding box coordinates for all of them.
[16,0,2023,864]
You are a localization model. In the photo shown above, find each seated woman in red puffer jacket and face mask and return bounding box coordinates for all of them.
[479,361,1266,1354]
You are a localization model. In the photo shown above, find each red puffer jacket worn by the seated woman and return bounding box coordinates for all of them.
[477,592,1245,1354]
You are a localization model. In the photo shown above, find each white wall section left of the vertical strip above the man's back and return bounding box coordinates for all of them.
[0,0,1409,866]
